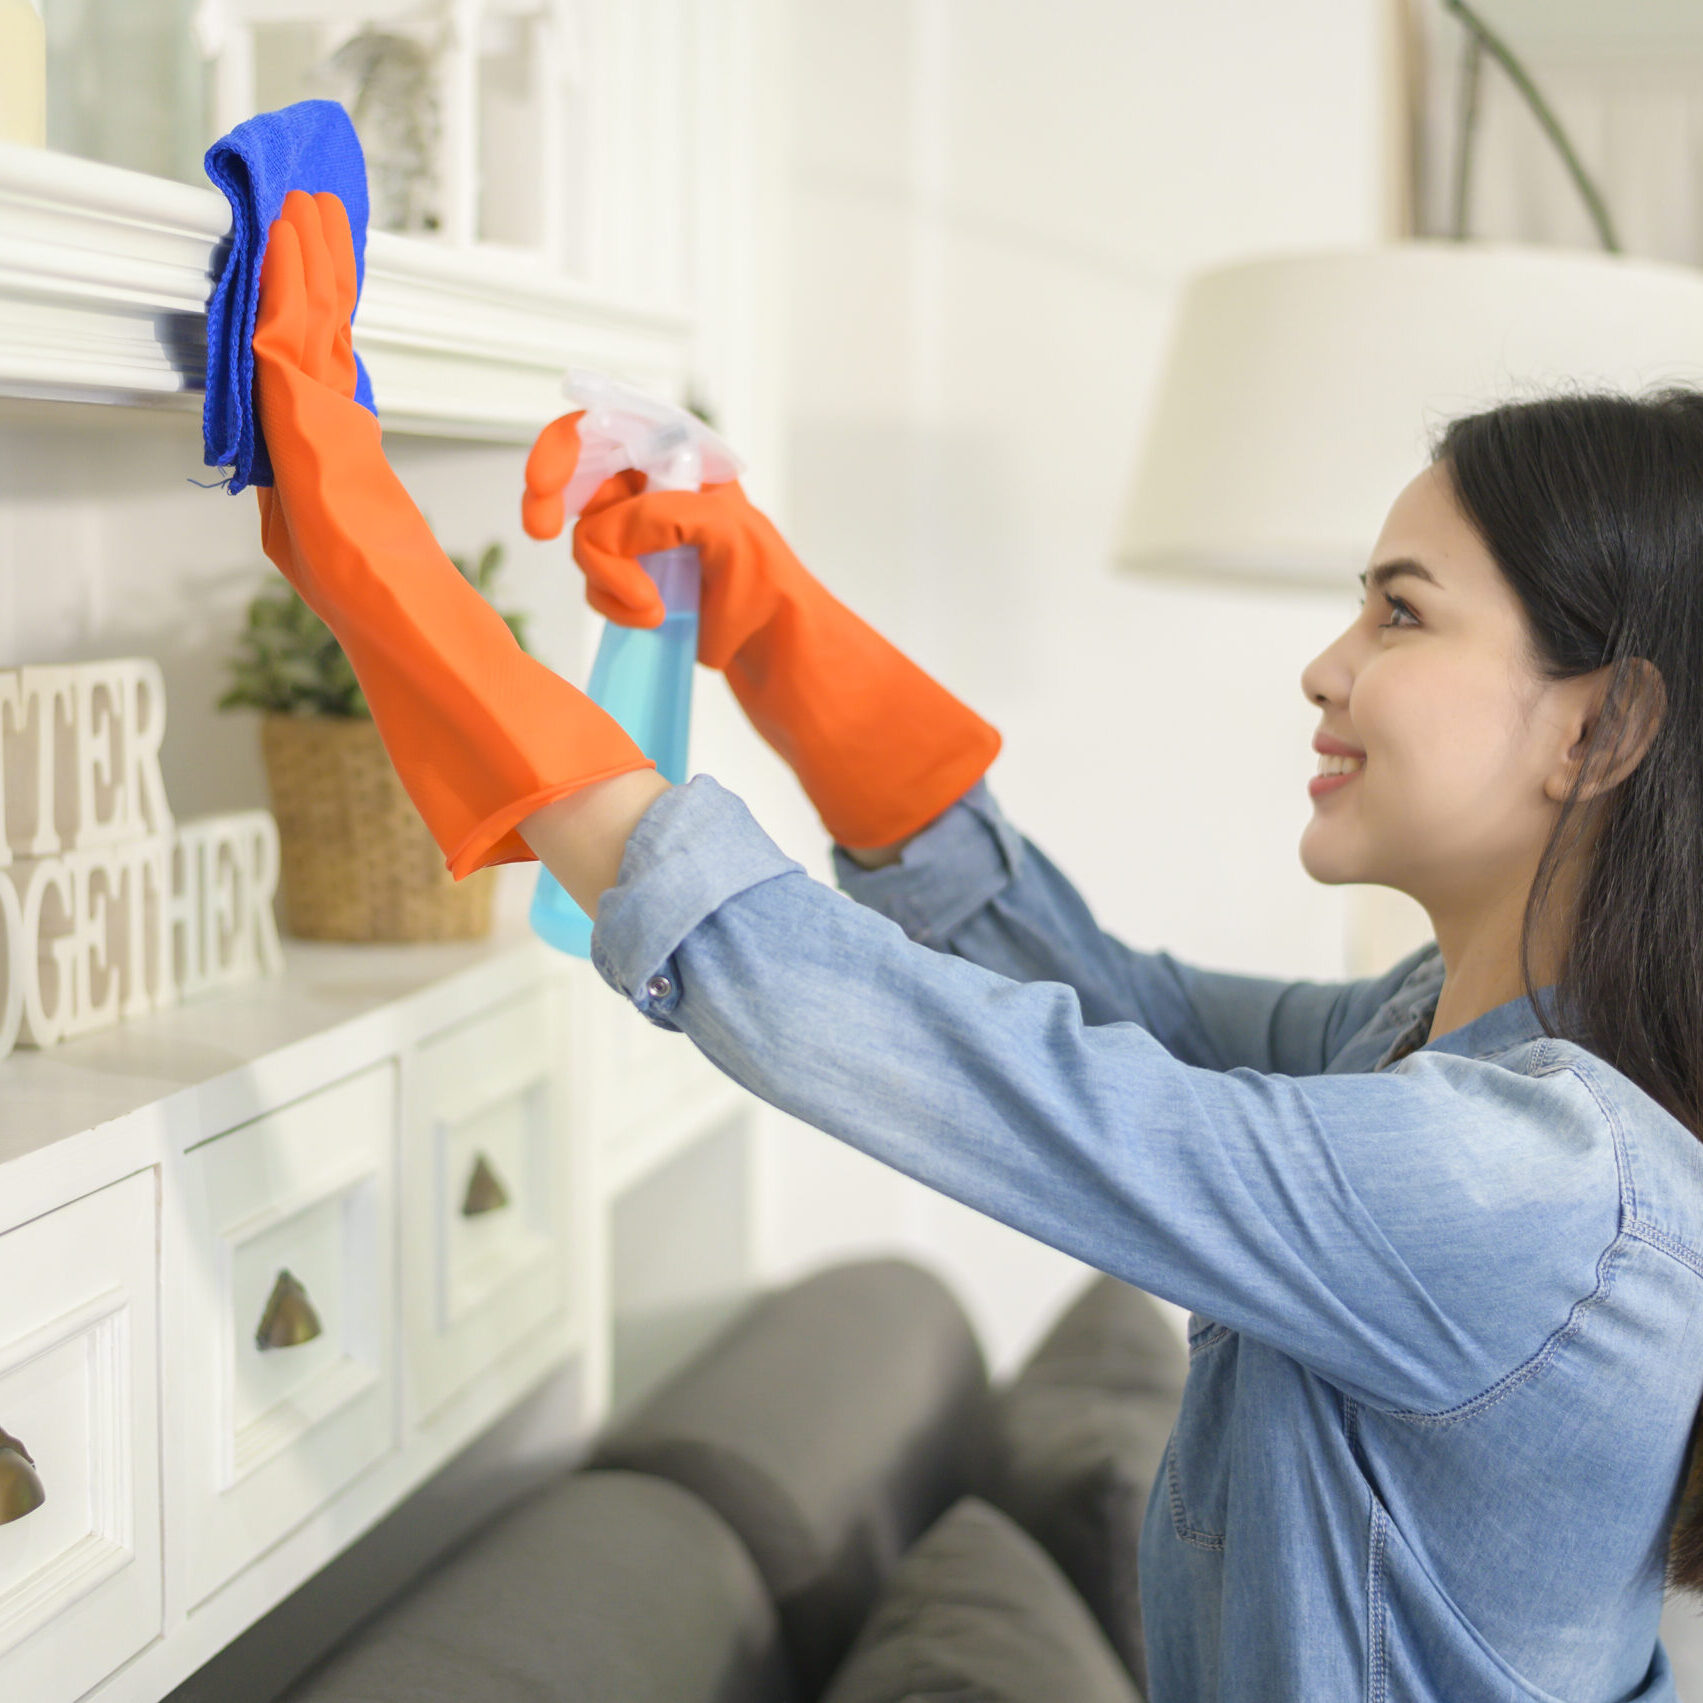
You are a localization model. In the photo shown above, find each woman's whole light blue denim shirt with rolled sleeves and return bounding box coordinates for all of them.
[593,775,1703,1703]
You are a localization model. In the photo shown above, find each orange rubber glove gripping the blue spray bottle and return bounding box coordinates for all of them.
[521,414,1000,848]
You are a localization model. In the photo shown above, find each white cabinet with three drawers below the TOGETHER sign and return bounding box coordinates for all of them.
[0,930,756,1703]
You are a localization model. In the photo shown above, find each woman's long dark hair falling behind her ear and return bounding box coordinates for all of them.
[1434,388,1703,1594]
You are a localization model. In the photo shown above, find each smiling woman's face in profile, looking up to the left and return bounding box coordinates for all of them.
[1301,467,1579,923]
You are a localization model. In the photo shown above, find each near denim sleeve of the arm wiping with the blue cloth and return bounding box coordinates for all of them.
[593,775,1618,1413]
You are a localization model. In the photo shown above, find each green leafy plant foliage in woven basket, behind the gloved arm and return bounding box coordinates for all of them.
[218,543,526,717]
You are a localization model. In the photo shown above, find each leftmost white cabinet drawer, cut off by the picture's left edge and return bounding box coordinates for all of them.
[0,1170,160,1703]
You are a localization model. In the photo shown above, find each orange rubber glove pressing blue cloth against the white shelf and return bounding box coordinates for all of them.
[254,189,656,879]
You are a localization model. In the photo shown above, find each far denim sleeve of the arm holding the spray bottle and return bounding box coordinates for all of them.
[833,780,1431,1075]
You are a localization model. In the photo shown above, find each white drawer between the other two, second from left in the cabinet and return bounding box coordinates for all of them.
[169,1061,397,1606]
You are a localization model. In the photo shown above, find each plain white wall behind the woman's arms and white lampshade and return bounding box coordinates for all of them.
[752,0,1393,1364]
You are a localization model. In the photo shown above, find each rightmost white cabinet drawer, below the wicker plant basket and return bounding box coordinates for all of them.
[402,986,572,1419]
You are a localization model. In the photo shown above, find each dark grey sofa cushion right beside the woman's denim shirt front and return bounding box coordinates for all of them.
[984,1277,1189,1684]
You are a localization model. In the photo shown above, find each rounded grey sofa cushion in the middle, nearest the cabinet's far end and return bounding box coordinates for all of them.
[594,1260,988,1696]
